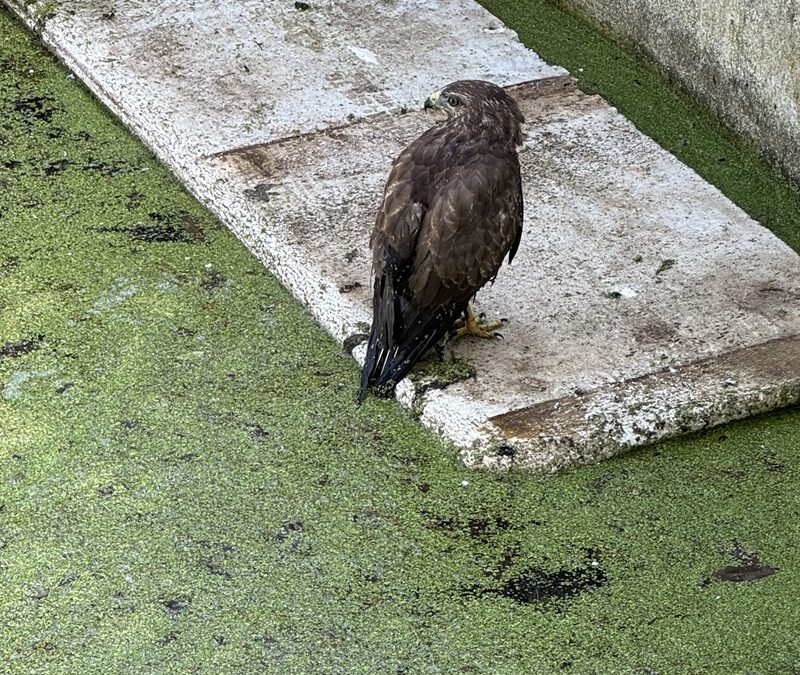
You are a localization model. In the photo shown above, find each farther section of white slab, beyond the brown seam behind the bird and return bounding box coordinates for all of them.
[6,0,564,162]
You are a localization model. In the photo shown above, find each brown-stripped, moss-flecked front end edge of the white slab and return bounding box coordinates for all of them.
[472,334,800,472]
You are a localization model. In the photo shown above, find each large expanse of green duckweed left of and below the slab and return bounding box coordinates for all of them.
[0,6,800,674]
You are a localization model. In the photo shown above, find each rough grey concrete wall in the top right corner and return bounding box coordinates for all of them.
[565,0,800,185]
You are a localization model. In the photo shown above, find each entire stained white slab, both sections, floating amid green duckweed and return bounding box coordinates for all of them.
[10,0,800,471]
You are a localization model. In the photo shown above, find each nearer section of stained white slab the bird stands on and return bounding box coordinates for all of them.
[211,77,800,470]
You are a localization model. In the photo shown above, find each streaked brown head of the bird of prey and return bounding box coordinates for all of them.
[424,80,525,142]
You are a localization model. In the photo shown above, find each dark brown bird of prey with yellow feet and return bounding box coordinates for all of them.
[358,80,524,403]
